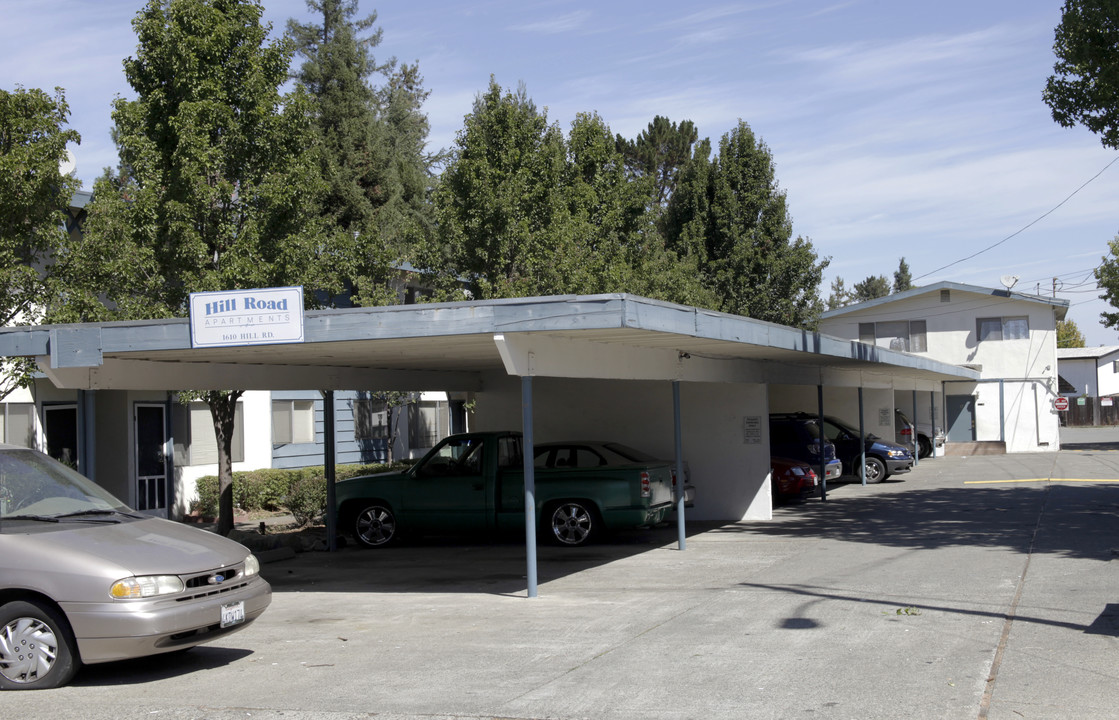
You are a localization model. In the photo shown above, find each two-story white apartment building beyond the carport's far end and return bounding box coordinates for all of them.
[820,282,1069,452]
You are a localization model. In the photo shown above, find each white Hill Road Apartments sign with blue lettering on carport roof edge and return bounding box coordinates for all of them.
[190,287,303,347]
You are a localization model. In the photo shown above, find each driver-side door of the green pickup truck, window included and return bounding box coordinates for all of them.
[402,437,489,534]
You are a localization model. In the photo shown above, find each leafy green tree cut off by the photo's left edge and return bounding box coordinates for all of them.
[0,85,82,399]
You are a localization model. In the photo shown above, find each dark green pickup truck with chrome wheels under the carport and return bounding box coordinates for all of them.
[336,432,673,548]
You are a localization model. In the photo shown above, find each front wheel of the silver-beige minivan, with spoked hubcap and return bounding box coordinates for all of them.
[0,600,82,690]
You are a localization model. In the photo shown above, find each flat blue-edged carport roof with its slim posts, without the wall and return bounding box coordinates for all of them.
[0,294,978,597]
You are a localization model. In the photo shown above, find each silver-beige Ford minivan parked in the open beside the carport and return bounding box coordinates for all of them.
[0,445,272,690]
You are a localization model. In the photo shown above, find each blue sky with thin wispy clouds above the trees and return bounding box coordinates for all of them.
[0,0,1119,345]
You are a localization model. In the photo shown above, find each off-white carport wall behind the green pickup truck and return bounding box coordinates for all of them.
[470,375,772,522]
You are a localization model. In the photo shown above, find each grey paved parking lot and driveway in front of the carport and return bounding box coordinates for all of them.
[0,429,1119,720]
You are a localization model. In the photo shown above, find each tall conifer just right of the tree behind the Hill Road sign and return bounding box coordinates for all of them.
[288,0,438,305]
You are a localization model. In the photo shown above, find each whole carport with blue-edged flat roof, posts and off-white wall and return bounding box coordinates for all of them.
[0,294,977,597]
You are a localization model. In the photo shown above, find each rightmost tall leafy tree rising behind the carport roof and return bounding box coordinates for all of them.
[665,121,828,327]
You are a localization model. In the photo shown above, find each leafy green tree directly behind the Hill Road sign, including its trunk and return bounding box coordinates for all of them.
[49,0,344,533]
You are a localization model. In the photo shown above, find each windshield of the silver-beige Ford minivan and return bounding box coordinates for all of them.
[0,448,131,521]
